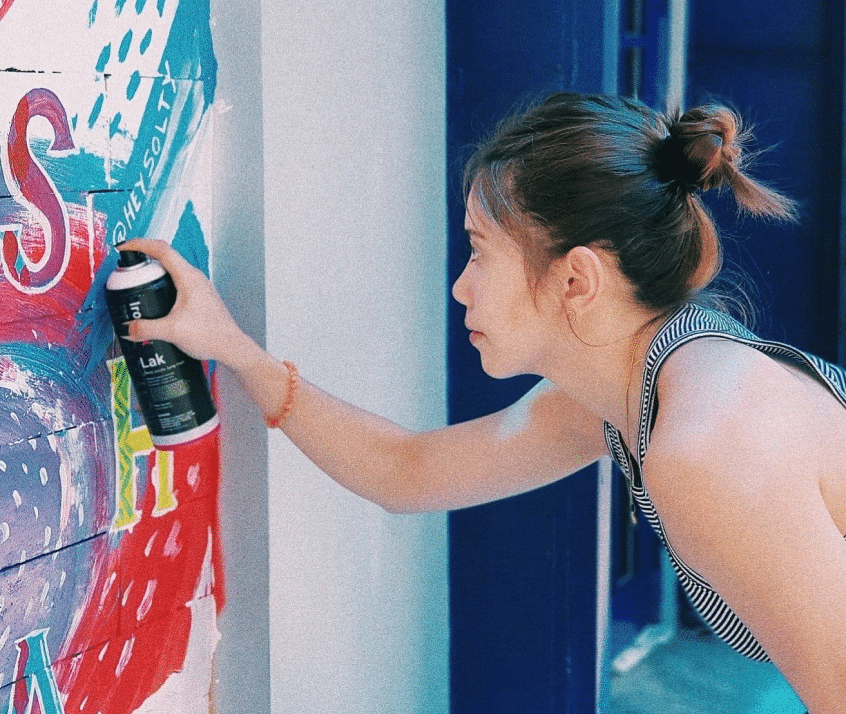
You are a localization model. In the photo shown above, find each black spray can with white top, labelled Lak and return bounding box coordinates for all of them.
[106,245,219,449]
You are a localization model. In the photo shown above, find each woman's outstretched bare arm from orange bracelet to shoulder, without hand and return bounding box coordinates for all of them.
[282,372,604,513]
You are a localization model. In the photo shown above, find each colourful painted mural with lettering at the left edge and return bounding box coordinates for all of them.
[0,0,223,714]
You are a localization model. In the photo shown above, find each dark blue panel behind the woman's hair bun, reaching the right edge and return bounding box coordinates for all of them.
[688,0,844,360]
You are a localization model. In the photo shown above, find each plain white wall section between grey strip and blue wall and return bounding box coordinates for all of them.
[261,0,448,714]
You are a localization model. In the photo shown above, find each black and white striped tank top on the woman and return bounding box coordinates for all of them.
[605,304,846,662]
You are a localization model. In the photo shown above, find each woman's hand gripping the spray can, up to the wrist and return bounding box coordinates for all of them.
[118,238,249,364]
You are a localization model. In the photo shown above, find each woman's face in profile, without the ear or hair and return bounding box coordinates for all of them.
[452,191,552,378]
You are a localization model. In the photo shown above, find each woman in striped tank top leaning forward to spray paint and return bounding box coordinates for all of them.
[122,94,846,714]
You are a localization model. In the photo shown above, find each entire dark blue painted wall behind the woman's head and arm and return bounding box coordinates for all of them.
[446,0,844,714]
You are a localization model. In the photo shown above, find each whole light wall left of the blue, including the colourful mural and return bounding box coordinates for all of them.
[0,0,448,714]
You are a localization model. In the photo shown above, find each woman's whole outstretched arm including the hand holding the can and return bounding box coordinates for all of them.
[119,240,605,512]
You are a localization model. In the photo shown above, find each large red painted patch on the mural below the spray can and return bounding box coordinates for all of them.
[56,432,224,714]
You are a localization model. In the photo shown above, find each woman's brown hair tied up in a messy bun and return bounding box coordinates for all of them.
[464,93,795,310]
